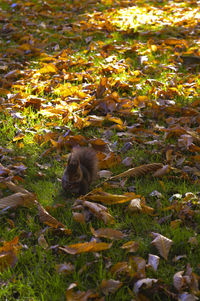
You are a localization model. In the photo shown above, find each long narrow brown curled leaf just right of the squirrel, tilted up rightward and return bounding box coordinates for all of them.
[111,163,163,180]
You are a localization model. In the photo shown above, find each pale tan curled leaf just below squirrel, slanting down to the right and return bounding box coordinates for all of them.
[83,201,114,224]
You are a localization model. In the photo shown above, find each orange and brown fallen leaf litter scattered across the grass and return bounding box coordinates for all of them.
[0,0,200,300]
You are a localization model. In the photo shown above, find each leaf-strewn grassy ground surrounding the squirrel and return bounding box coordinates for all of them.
[0,0,200,301]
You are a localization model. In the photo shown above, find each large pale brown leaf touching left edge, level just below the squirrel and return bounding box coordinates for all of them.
[0,192,35,209]
